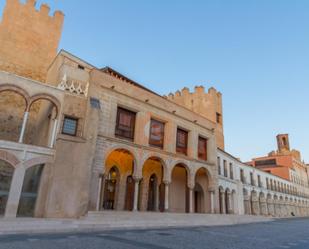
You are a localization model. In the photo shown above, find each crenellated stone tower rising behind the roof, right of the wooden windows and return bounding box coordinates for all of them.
[167,86,224,150]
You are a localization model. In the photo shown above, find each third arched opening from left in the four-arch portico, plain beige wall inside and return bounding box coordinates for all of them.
[169,164,189,213]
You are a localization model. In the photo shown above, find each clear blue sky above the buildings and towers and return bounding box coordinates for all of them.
[0,0,309,162]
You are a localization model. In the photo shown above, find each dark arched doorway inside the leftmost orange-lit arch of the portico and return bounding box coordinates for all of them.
[103,166,120,210]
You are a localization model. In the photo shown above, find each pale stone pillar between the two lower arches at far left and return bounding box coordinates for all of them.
[4,166,26,218]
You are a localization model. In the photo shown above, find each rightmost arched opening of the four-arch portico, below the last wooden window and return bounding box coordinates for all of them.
[193,168,211,213]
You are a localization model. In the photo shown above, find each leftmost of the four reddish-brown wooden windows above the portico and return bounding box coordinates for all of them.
[115,107,136,140]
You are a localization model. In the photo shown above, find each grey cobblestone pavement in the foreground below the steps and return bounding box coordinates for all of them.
[0,219,309,249]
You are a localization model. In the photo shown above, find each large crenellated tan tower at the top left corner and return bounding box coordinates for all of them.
[0,0,64,82]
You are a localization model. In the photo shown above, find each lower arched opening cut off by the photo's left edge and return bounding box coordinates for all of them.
[0,159,14,216]
